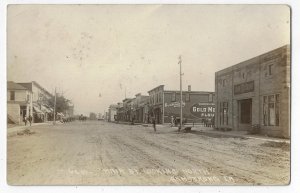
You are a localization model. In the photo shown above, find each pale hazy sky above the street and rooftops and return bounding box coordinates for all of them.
[7,5,290,114]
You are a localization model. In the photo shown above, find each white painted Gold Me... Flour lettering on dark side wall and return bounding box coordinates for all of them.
[190,103,215,118]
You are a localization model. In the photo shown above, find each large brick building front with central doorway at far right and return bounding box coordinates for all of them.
[215,45,290,137]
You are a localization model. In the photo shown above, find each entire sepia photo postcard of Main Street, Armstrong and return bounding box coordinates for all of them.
[6,4,291,186]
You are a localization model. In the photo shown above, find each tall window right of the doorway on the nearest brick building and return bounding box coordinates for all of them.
[263,94,280,126]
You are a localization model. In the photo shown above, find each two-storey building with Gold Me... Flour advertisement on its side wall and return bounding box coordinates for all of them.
[148,85,215,124]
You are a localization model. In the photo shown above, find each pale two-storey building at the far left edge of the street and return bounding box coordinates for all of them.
[7,81,33,124]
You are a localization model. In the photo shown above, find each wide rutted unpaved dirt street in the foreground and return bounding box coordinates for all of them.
[7,121,290,185]
